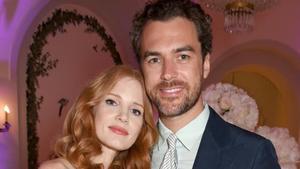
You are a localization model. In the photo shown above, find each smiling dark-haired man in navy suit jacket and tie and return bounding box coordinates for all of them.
[131,0,280,169]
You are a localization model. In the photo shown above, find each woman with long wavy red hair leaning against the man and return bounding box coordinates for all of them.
[40,66,157,169]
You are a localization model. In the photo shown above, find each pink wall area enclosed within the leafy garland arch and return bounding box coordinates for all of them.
[38,18,119,161]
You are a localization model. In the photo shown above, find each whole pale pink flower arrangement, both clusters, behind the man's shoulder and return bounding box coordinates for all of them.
[202,83,300,169]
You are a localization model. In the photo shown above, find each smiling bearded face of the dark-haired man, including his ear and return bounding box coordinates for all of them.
[140,17,210,117]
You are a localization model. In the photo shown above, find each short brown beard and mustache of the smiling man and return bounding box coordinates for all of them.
[148,79,201,117]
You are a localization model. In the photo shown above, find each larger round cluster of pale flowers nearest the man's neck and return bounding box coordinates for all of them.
[202,83,258,131]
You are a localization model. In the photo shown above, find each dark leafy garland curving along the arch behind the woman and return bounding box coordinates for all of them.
[26,9,122,169]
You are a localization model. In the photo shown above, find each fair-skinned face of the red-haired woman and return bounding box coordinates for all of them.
[94,77,144,152]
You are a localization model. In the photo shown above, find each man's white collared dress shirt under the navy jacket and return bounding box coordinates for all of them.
[151,104,209,169]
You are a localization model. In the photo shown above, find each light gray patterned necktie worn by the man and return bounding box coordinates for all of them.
[160,134,177,169]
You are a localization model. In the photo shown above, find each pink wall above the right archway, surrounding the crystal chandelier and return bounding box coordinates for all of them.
[207,0,300,60]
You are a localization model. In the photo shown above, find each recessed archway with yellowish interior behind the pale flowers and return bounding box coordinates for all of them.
[205,40,300,138]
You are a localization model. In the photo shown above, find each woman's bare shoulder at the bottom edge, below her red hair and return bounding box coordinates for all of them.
[39,158,73,169]
